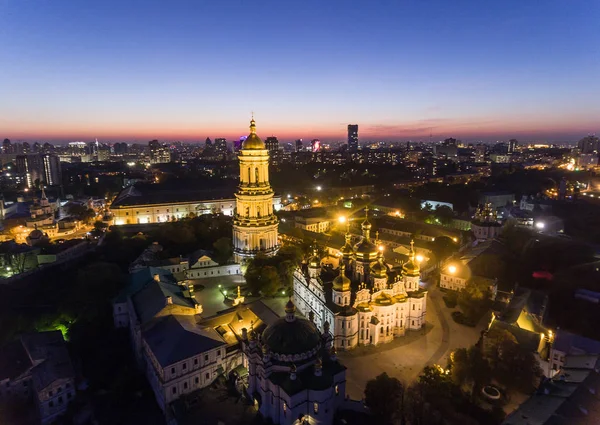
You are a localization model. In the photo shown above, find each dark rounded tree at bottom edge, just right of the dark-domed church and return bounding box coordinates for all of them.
[365,372,404,424]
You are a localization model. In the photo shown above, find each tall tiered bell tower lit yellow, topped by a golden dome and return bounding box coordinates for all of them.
[233,118,279,262]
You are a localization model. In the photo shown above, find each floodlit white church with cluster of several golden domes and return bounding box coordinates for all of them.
[294,210,427,350]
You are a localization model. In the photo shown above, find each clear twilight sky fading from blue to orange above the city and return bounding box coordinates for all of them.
[0,0,600,141]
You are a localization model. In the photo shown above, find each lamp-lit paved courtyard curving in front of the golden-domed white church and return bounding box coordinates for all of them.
[338,288,489,399]
